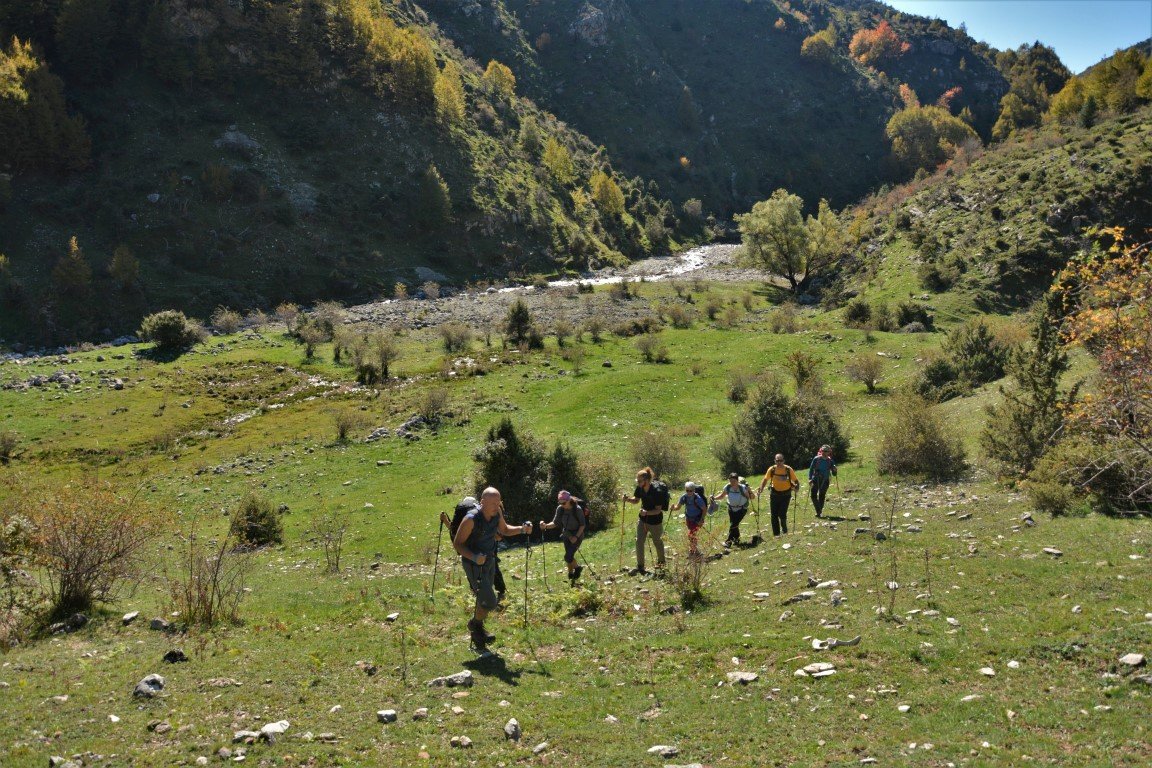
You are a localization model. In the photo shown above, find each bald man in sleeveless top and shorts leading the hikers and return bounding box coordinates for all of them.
[452,487,532,653]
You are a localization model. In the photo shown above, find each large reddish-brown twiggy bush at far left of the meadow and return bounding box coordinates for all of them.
[28,480,160,618]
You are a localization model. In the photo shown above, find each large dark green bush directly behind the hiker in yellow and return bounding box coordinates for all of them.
[713,379,850,476]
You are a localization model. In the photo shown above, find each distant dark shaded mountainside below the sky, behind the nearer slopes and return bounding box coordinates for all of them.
[424,0,1008,214]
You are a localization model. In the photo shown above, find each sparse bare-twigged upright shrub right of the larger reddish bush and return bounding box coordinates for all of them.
[168,525,251,628]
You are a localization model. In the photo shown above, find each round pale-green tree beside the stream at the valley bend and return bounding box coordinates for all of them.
[735,189,844,294]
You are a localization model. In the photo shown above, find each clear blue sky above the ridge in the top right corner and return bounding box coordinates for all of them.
[884,0,1152,73]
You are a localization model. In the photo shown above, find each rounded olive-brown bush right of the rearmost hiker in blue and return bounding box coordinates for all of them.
[877,393,965,480]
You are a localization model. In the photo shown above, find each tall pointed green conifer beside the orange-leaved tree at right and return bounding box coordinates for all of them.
[980,295,1077,476]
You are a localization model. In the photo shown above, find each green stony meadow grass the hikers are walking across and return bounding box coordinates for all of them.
[0,283,1152,766]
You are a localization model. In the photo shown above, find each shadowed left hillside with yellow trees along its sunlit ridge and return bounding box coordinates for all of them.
[0,0,681,342]
